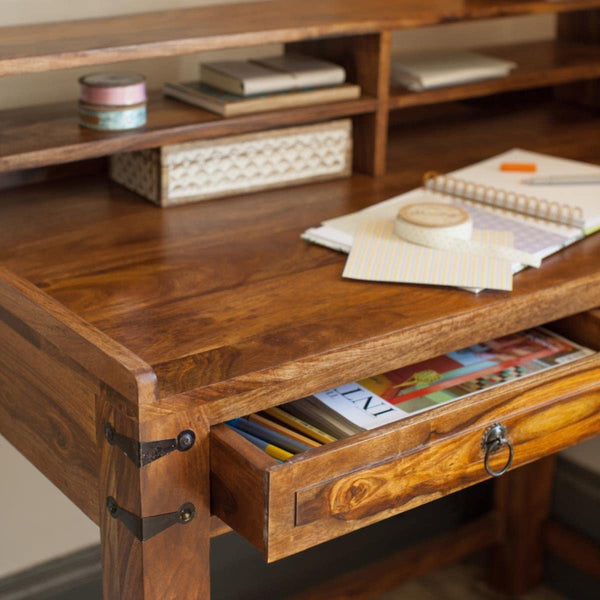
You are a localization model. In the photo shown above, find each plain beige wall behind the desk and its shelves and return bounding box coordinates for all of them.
[0,0,568,577]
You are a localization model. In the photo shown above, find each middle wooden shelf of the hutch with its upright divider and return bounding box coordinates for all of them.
[5,37,600,175]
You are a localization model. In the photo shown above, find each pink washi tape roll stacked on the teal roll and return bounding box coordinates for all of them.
[79,73,146,106]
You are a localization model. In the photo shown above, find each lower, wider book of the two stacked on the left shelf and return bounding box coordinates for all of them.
[163,81,360,117]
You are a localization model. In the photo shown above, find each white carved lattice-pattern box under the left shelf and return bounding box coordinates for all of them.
[110,119,352,206]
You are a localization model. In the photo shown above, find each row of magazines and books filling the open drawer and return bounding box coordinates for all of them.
[227,328,594,461]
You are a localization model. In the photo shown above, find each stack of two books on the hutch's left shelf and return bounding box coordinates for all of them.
[163,53,360,116]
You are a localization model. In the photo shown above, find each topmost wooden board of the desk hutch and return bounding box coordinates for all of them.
[0,0,599,75]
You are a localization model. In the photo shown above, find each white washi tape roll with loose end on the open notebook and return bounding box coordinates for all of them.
[395,202,541,267]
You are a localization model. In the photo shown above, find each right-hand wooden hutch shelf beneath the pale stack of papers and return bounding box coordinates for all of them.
[390,40,600,109]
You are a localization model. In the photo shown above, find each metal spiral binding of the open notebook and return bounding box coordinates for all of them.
[423,171,583,225]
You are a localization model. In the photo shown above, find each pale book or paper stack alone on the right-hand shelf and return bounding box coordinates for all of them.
[391,50,517,92]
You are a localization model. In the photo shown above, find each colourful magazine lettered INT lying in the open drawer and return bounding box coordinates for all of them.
[283,328,593,438]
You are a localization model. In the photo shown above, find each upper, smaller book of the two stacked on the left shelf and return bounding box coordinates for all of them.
[200,53,346,96]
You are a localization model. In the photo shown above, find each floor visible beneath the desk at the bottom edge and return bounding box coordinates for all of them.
[377,562,565,600]
